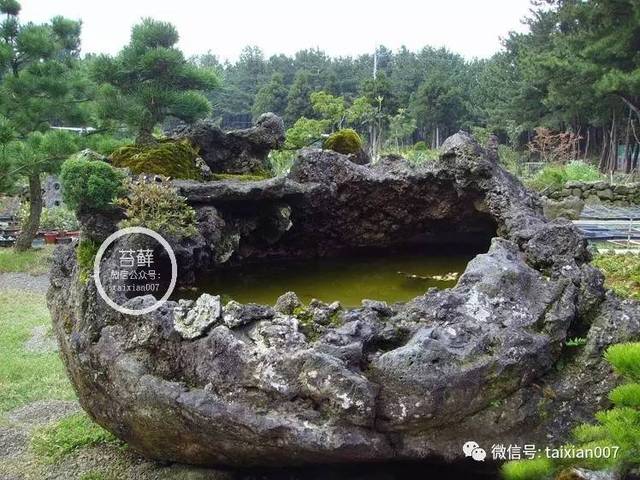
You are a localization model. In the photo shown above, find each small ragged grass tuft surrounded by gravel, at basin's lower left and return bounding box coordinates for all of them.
[31,413,121,462]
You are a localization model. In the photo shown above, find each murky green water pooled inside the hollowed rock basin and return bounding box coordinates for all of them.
[177,254,473,307]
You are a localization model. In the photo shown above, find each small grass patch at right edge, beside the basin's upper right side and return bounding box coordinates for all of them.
[593,253,640,300]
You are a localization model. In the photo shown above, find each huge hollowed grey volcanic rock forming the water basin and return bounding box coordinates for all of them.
[48,134,640,467]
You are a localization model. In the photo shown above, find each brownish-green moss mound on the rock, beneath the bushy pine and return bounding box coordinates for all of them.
[111,140,202,180]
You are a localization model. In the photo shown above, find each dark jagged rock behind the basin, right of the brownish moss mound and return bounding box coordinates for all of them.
[173,113,284,174]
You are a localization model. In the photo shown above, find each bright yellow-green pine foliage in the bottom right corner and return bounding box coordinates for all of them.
[502,342,640,480]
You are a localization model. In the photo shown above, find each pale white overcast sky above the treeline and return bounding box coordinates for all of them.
[21,0,529,60]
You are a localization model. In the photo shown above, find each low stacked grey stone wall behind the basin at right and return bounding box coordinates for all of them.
[546,180,640,206]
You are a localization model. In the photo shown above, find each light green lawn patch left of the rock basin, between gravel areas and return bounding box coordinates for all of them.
[0,291,75,412]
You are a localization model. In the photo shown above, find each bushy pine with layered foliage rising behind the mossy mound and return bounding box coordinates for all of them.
[92,18,219,144]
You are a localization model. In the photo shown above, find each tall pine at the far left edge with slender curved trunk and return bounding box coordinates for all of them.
[0,0,88,250]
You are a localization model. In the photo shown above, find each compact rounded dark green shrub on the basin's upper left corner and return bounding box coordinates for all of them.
[60,158,124,211]
